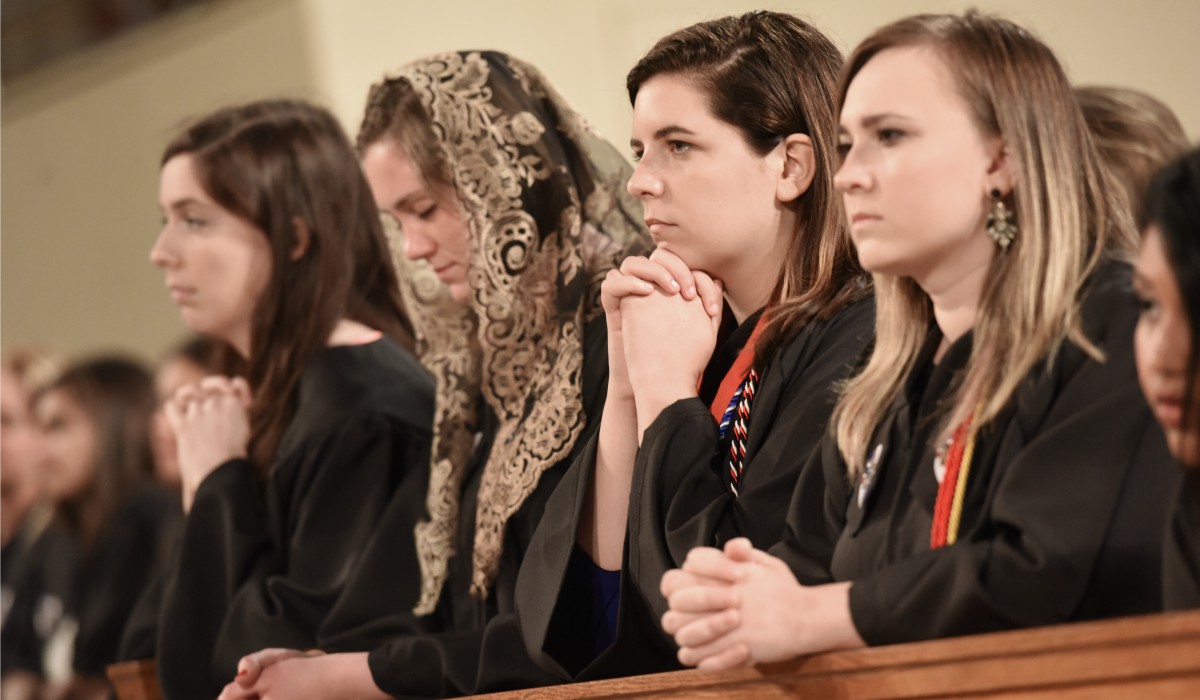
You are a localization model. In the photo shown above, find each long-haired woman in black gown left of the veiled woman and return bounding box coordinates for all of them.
[150,101,433,699]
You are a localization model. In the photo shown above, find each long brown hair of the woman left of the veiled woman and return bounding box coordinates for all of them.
[162,100,412,473]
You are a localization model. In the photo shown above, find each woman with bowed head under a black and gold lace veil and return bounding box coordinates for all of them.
[223,52,650,698]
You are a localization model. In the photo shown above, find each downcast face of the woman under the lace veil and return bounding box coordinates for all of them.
[362,139,470,303]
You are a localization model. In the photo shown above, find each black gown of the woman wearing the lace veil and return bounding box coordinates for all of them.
[320,317,608,698]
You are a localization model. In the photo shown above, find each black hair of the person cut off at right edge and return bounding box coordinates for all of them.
[1138,149,1200,423]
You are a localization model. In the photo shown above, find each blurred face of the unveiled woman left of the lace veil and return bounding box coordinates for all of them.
[150,154,271,355]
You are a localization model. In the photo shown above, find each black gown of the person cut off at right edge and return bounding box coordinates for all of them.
[1163,468,1200,610]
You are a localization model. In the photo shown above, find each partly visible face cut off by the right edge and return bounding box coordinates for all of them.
[1133,226,1200,467]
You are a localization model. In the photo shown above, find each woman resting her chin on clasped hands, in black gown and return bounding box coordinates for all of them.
[508,12,872,680]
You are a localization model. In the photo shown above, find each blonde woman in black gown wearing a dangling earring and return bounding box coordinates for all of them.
[662,13,1174,668]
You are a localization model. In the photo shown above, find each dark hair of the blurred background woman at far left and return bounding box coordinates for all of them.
[37,357,156,548]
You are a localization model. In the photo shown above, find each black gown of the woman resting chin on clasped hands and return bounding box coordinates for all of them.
[517,299,875,681]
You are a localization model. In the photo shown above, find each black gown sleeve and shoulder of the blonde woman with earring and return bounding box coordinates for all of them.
[850,273,1170,645]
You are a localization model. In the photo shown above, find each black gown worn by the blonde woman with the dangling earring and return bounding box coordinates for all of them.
[776,264,1176,645]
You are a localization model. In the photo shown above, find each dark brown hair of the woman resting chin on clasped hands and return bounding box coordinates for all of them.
[625,11,870,363]
